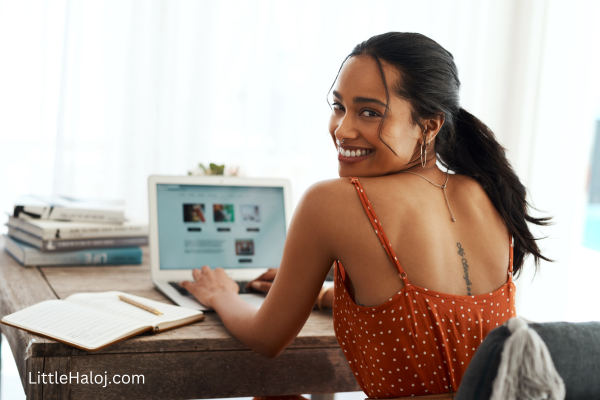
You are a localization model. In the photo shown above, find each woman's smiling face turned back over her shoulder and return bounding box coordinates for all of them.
[329,56,422,177]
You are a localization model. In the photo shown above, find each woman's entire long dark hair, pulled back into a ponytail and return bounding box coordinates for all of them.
[340,32,551,276]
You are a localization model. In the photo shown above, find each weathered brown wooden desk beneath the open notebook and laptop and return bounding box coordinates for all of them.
[0,237,360,400]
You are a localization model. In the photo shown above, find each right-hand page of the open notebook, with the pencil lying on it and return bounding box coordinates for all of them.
[65,291,202,326]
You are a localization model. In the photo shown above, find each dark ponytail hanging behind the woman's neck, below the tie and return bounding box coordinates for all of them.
[435,108,551,275]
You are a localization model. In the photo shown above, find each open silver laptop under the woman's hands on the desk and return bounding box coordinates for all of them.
[148,176,292,311]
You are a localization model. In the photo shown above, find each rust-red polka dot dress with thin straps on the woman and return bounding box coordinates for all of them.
[333,178,516,398]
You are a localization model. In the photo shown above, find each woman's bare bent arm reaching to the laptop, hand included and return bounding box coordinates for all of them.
[182,182,336,357]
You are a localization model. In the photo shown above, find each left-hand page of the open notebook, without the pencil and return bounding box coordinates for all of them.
[3,300,149,349]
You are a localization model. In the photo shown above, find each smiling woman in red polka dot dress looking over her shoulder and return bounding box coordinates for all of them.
[182,32,547,398]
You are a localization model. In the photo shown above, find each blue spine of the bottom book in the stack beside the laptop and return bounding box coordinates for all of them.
[23,247,142,266]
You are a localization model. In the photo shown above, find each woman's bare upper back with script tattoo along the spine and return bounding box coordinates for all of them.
[328,171,509,305]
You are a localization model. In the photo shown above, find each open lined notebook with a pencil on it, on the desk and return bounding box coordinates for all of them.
[0,292,204,351]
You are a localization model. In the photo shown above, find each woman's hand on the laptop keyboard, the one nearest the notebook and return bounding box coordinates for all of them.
[179,265,240,308]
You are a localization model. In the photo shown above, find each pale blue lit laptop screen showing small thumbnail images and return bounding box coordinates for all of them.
[156,184,286,270]
